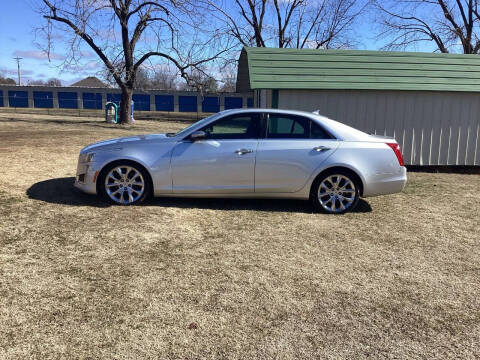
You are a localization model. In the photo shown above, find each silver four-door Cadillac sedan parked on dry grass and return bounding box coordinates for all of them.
[75,109,407,214]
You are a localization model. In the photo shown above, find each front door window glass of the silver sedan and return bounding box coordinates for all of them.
[201,114,259,139]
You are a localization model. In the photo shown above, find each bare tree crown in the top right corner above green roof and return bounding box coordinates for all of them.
[374,0,480,54]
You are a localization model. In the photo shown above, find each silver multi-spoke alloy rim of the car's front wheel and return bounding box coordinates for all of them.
[105,166,145,205]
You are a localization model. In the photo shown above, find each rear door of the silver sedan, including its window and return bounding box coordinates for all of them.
[255,113,338,193]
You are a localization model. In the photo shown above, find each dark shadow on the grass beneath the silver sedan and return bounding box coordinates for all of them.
[26,177,372,213]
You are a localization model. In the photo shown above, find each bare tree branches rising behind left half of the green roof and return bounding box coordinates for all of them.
[209,0,367,49]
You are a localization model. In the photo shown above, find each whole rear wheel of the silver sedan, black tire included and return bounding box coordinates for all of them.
[310,169,360,214]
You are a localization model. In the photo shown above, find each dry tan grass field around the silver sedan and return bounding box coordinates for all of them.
[0,113,480,359]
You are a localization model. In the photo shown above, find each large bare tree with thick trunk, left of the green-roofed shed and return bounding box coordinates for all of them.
[40,0,228,122]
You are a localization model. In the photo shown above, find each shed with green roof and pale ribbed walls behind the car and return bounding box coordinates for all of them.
[237,48,480,165]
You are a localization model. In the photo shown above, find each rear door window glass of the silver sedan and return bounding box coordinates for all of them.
[267,114,310,139]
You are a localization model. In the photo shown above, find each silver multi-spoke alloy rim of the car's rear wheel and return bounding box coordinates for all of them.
[318,174,355,213]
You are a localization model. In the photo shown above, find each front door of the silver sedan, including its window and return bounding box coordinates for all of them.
[171,113,260,194]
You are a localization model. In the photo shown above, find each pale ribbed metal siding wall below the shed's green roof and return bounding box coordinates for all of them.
[279,90,480,165]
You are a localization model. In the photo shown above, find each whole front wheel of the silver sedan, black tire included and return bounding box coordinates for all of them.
[98,160,152,206]
